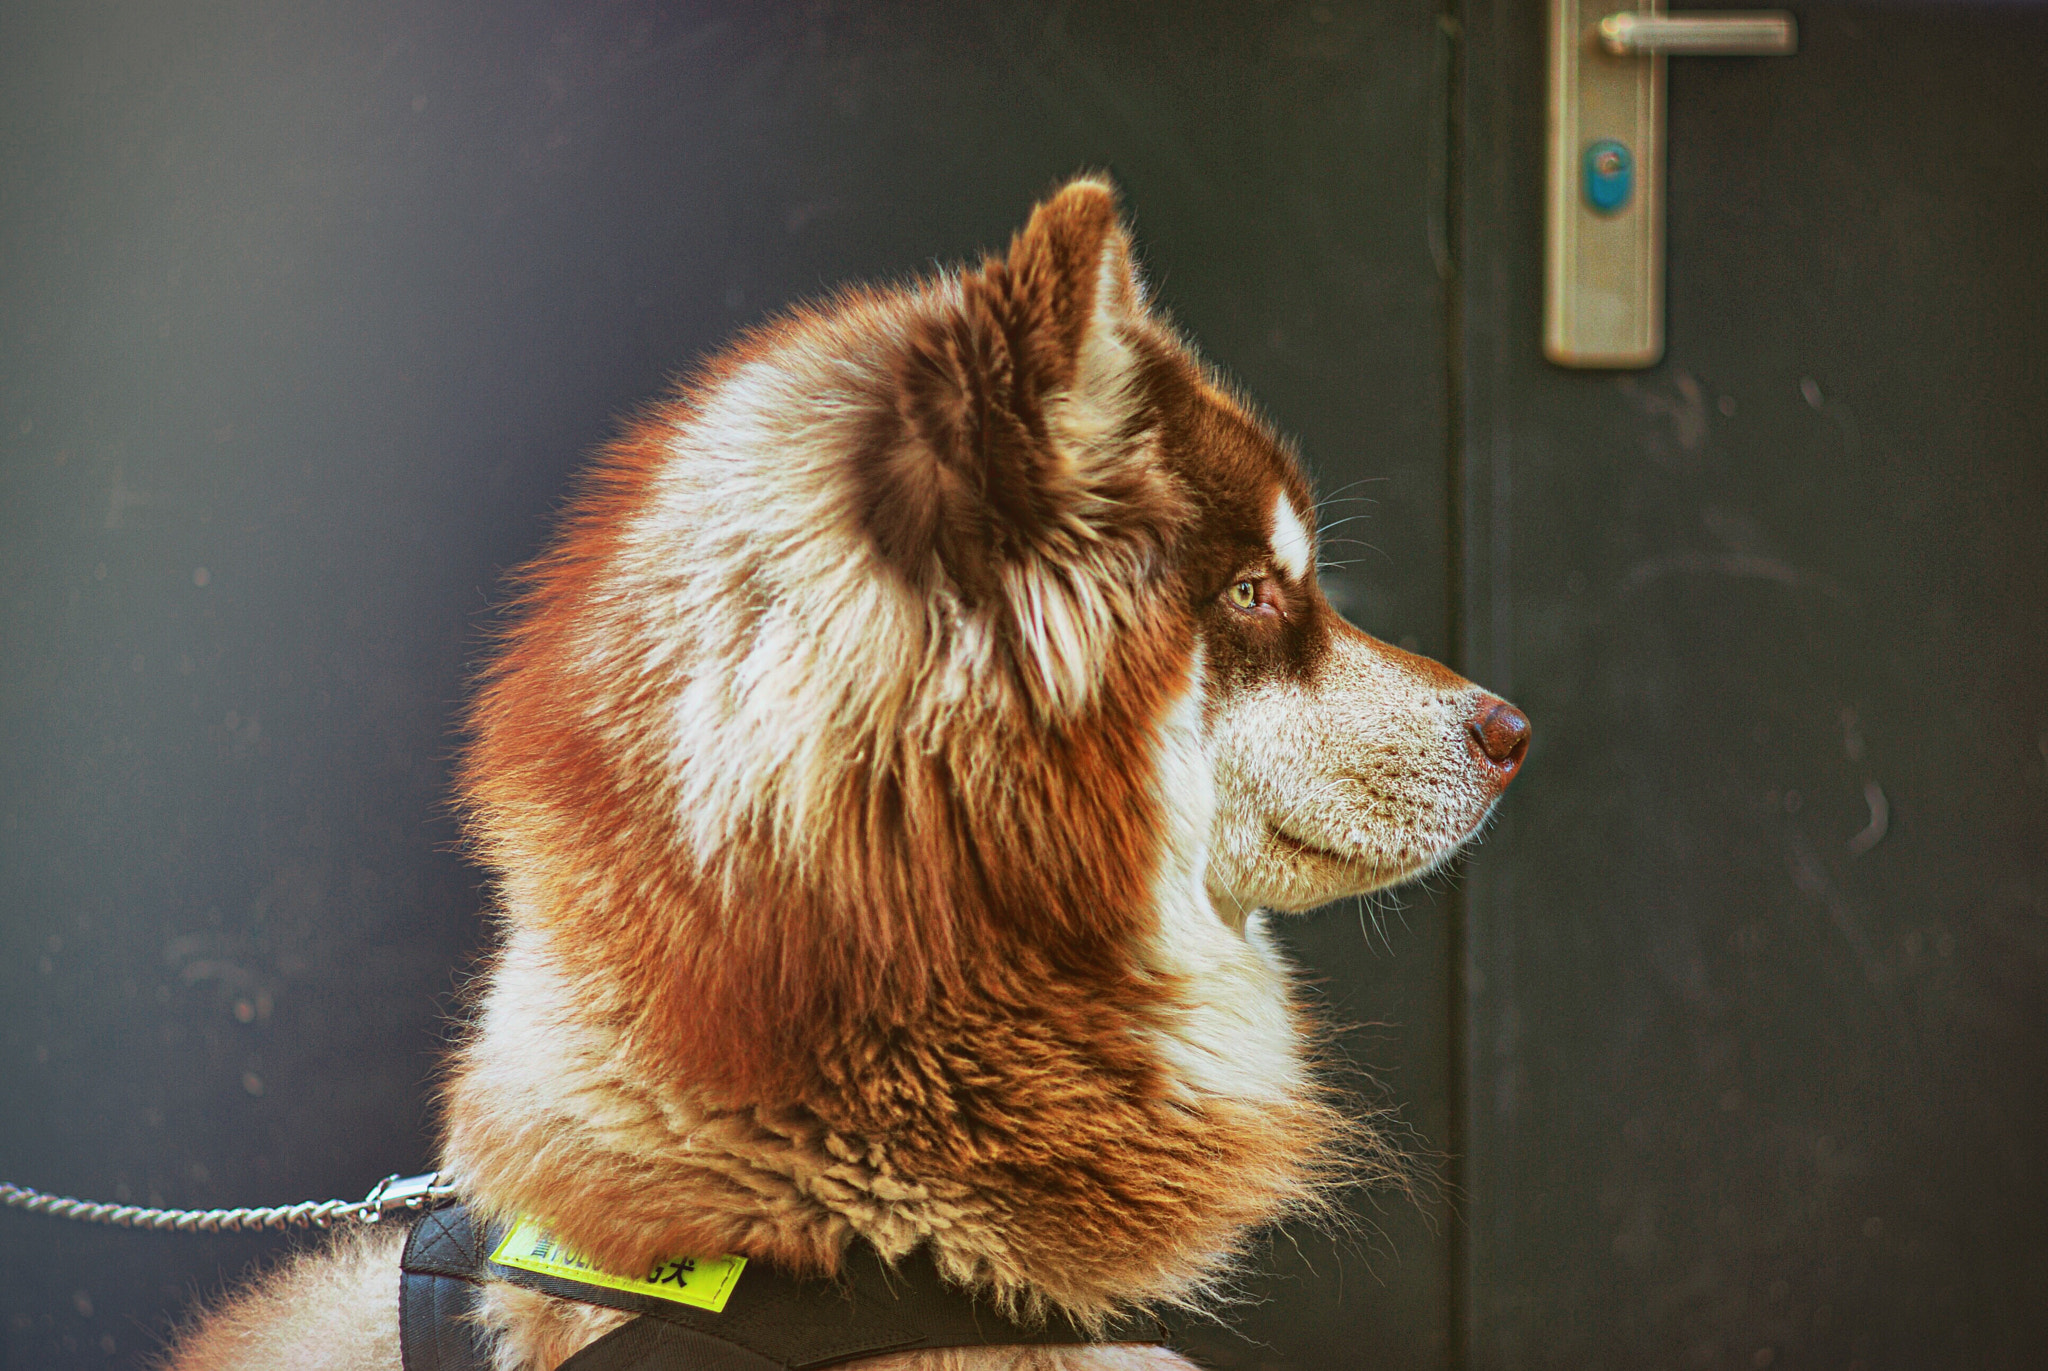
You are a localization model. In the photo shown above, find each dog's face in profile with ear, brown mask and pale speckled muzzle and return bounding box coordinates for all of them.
[839,180,1528,918]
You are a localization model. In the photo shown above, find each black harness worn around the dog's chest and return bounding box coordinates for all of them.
[399,1205,1174,1371]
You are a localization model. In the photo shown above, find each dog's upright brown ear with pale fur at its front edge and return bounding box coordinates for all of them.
[866,178,1161,605]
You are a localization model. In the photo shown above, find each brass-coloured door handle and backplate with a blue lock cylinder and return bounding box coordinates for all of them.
[1544,0,1798,367]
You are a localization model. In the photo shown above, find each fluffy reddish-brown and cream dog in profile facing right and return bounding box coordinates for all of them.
[172,176,1530,1371]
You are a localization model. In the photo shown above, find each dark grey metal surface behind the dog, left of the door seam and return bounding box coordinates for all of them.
[0,0,1452,1367]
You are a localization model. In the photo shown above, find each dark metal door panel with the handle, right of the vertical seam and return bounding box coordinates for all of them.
[1458,0,2048,1369]
